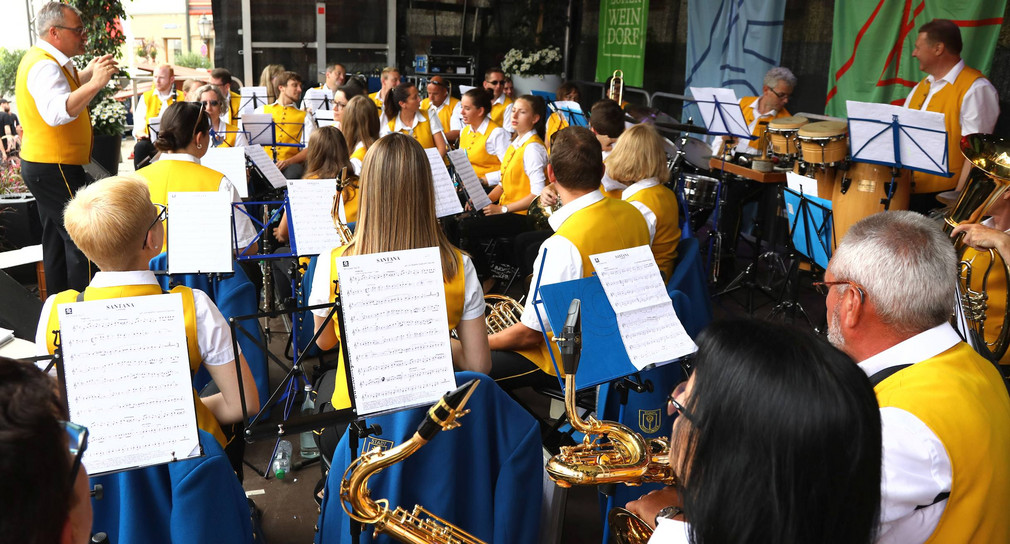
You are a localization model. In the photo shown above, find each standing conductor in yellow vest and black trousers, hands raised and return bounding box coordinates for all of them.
[15,2,118,293]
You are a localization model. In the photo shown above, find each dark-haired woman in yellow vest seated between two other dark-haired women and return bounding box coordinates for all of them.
[460,88,509,179]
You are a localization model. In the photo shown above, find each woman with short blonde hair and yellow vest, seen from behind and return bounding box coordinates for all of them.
[607,124,681,280]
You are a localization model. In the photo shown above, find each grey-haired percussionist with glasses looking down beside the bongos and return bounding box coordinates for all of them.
[712,67,796,156]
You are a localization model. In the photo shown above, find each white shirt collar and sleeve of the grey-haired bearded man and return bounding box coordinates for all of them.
[860,323,961,544]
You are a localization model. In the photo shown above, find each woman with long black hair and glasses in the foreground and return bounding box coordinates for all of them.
[628,320,882,544]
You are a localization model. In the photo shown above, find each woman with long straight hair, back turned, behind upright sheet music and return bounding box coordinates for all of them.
[309,133,491,410]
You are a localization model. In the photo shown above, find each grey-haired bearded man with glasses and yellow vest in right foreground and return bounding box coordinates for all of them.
[819,211,1010,544]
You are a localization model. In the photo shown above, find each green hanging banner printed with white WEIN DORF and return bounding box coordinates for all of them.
[596,0,648,87]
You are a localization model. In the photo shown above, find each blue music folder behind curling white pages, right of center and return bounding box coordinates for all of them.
[539,275,675,391]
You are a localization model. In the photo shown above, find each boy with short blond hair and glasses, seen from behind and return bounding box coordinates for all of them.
[35,176,260,446]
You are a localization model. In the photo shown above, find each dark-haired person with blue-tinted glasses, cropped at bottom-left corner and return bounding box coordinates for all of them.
[0,357,92,544]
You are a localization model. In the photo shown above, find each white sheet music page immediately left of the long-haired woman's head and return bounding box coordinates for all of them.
[288,180,340,256]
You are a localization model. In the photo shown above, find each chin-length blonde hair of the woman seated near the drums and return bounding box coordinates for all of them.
[607,124,670,184]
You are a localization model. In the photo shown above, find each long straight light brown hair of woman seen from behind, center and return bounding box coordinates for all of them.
[346,132,460,281]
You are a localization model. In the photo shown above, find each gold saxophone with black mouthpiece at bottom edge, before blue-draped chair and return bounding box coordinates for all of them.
[340,379,484,544]
